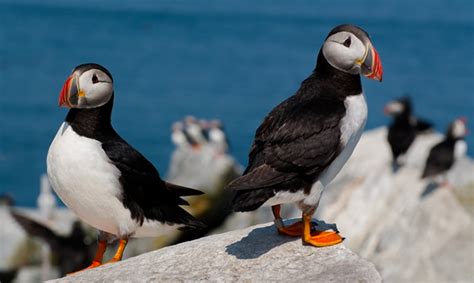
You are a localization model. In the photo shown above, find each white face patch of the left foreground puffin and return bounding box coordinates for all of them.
[77,69,114,108]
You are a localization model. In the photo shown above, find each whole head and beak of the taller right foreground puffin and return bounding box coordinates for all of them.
[322,24,383,81]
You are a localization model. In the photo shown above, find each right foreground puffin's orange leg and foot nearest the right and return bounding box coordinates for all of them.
[302,211,344,247]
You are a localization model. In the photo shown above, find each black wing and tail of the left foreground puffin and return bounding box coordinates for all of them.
[102,137,203,228]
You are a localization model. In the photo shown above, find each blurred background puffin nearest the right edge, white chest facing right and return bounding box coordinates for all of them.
[421,117,468,182]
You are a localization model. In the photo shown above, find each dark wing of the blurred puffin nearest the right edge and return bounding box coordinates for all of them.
[422,141,454,178]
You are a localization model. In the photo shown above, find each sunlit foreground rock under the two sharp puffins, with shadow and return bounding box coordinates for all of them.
[51,224,382,282]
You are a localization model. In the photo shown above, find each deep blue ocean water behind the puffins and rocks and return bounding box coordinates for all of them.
[0,0,474,206]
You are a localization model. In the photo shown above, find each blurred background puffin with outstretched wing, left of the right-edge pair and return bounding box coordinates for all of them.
[384,96,431,168]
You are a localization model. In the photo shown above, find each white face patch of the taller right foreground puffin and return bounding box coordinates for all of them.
[323,31,367,74]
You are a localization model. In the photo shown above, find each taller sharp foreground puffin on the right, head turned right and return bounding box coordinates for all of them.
[227,24,383,247]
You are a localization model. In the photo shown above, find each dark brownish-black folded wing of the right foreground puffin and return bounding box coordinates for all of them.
[229,96,345,190]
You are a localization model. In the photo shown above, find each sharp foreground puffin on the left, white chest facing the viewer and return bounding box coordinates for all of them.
[47,63,204,268]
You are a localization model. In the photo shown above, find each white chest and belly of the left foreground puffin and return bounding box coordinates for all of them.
[47,122,130,234]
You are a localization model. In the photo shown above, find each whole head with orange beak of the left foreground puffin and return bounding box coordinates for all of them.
[59,63,114,108]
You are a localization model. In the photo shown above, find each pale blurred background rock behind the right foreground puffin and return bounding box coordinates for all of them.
[218,128,474,283]
